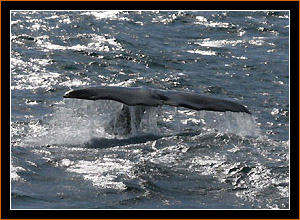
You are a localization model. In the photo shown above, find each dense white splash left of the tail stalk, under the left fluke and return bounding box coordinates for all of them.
[29,100,113,145]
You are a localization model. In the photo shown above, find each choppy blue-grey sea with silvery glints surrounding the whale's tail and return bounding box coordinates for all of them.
[11,11,290,209]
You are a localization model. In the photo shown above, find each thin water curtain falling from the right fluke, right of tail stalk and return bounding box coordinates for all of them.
[161,107,262,137]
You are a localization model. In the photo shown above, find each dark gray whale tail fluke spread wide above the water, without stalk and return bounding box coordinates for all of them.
[64,86,251,114]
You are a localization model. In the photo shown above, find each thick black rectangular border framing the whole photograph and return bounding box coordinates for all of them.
[1,1,299,219]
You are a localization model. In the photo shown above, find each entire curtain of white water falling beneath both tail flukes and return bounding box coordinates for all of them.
[30,99,261,145]
